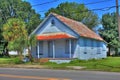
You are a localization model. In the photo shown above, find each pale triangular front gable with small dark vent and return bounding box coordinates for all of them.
[31,14,79,37]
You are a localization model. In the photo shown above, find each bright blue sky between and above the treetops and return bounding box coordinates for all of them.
[25,0,120,18]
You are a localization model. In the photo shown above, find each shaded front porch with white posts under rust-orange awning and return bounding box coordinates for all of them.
[32,34,76,59]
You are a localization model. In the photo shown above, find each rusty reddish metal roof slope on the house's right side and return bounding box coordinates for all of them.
[50,13,103,41]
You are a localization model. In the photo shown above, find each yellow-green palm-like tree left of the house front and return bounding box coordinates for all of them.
[2,18,28,58]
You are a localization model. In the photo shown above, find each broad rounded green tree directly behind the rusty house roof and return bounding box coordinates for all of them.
[45,2,99,29]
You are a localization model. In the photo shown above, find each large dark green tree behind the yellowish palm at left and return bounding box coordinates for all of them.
[0,0,41,40]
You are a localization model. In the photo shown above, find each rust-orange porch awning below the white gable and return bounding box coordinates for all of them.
[37,33,75,40]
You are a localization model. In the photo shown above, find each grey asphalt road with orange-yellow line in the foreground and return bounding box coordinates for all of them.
[0,68,120,80]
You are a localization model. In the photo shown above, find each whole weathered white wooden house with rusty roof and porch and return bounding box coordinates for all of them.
[31,13,107,60]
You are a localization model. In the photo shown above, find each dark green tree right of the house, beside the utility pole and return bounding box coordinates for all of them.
[100,13,120,56]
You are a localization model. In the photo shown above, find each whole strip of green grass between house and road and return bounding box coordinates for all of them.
[0,57,120,72]
